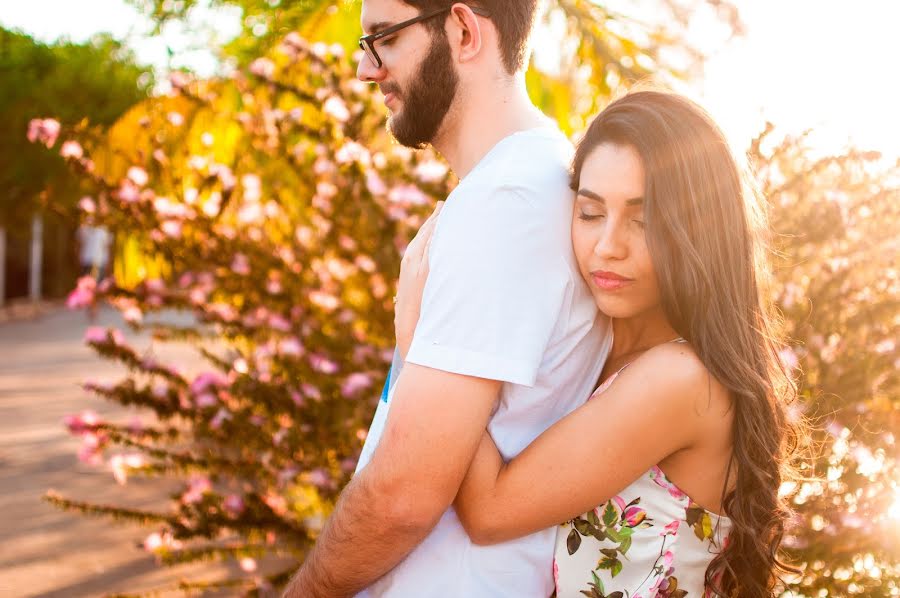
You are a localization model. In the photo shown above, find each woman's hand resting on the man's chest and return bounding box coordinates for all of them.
[394,201,444,359]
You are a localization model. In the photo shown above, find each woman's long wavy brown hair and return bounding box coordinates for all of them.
[572,91,796,598]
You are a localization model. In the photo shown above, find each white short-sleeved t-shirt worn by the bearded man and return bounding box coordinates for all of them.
[359,127,612,598]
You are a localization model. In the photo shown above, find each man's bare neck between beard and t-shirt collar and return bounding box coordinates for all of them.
[432,78,548,179]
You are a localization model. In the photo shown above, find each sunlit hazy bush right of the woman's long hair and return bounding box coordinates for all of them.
[751,127,900,596]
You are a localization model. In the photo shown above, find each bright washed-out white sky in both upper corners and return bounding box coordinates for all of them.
[0,0,900,158]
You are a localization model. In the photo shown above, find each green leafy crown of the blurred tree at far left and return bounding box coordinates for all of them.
[0,28,152,229]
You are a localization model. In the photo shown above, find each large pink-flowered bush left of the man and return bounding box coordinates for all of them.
[39,35,449,589]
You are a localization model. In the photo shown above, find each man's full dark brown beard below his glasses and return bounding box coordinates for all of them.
[388,33,459,148]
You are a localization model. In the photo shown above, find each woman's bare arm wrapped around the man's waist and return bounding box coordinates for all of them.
[454,344,721,544]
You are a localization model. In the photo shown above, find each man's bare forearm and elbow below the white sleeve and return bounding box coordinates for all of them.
[284,363,501,598]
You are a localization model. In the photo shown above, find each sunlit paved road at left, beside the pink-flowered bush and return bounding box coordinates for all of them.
[0,309,244,598]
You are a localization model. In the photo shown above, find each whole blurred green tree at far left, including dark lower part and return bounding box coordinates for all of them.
[0,28,153,303]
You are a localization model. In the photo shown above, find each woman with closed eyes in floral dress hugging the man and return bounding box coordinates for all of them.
[398,91,793,598]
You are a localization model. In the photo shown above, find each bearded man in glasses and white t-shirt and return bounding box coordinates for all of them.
[285,0,611,598]
